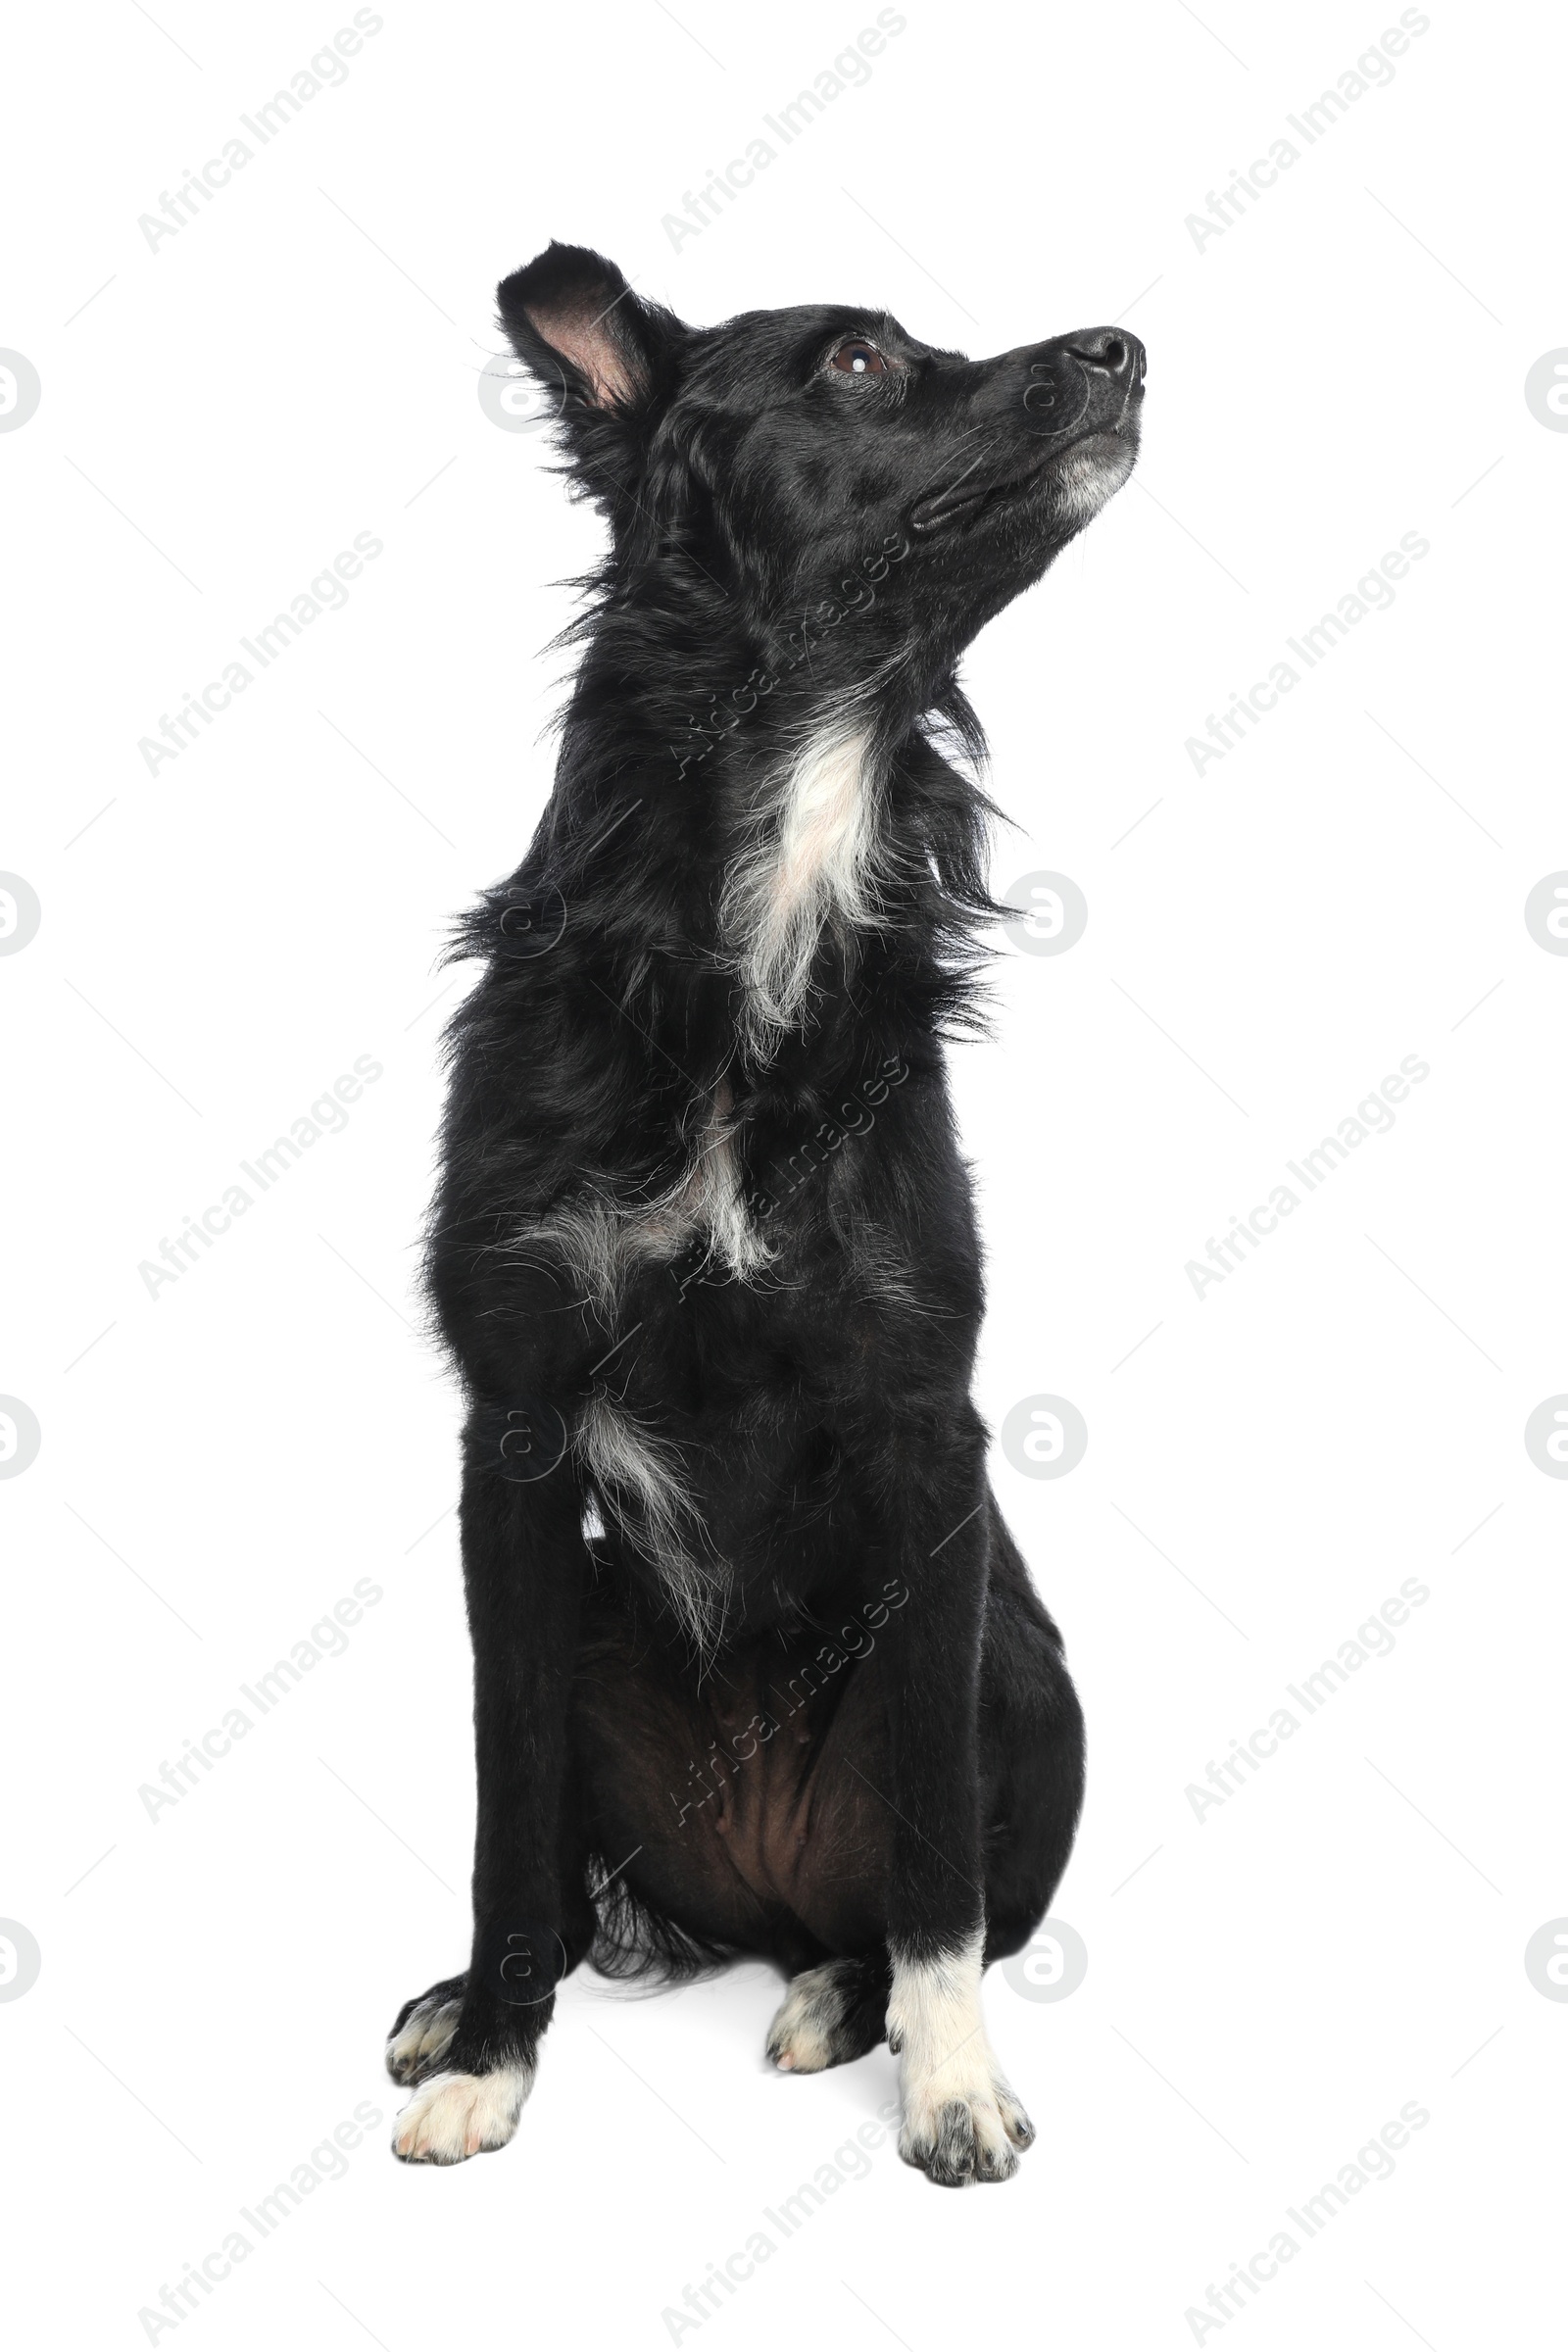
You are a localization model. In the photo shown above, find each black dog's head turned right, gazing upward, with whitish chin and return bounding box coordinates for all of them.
[501,245,1145,661]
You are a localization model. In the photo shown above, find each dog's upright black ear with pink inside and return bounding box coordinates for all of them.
[496,245,686,452]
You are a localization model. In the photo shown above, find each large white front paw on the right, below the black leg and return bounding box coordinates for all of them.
[889,1936,1034,2187]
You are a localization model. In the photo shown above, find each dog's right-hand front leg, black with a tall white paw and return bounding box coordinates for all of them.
[886,1442,1034,2187]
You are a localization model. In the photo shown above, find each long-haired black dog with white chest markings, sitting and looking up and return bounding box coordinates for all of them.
[388,245,1143,2185]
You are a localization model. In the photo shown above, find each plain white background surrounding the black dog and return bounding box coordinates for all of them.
[0,0,1568,2352]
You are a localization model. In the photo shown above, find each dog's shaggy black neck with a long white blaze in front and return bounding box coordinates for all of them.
[543,605,990,1070]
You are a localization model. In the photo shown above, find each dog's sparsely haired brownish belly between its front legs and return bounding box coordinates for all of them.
[573,1606,894,1954]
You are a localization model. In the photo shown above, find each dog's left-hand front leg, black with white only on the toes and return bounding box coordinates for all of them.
[393,1411,583,2164]
